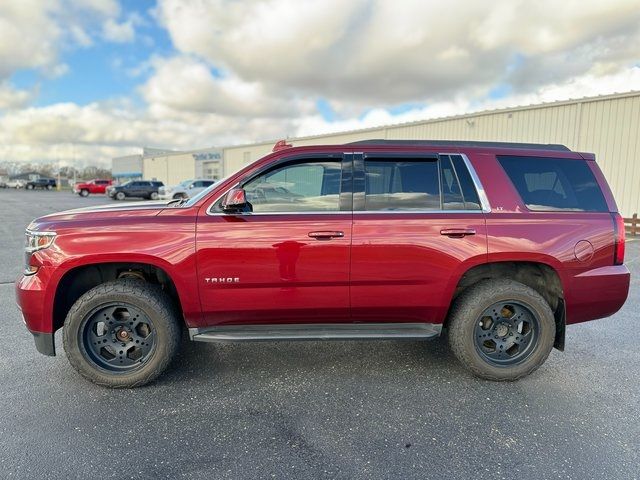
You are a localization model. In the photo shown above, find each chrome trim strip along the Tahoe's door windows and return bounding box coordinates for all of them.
[207,152,491,217]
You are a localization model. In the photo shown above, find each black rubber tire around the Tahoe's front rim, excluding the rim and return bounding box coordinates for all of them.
[63,279,182,388]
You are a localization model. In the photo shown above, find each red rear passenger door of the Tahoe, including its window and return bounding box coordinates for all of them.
[351,152,487,323]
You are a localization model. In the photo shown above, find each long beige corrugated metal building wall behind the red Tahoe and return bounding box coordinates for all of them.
[224,92,640,216]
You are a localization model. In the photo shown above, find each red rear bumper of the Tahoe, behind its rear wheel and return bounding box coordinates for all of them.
[567,265,631,324]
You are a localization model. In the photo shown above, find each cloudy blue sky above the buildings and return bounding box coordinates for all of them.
[0,0,640,166]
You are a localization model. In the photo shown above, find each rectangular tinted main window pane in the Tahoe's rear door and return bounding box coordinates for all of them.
[364,159,440,210]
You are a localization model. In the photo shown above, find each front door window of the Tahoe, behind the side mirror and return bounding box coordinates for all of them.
[243,161,341,212]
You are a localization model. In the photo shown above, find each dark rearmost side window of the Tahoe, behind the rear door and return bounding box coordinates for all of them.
[498,156,608,212]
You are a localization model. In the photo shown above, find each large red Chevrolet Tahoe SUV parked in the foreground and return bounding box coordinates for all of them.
[16,140,629,387]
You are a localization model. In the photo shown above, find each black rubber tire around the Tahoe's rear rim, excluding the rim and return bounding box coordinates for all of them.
[448,279,556,381]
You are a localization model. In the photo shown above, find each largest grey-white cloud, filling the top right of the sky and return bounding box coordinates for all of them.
[157,0,640,106]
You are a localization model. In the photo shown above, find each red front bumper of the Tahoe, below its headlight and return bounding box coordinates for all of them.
[16,267,56,356]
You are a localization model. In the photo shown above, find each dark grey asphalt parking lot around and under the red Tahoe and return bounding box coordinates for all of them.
[0,190,640,479]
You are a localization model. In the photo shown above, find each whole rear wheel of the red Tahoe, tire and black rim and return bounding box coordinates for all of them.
[448,280,556,381]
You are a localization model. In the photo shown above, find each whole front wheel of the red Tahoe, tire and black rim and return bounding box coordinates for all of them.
[63,279,181,388]
